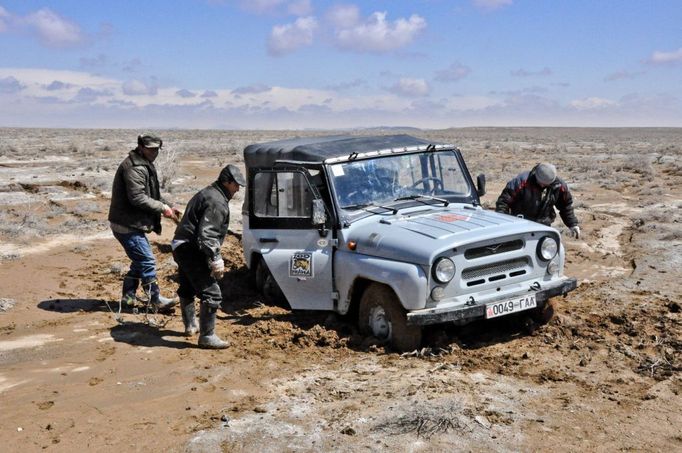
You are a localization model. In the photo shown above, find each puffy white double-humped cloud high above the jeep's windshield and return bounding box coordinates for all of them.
[332,8,426,52]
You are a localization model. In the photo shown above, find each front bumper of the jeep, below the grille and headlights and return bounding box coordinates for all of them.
[407,277,578,326]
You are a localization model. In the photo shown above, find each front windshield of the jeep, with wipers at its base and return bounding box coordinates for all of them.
[330,150,474,211]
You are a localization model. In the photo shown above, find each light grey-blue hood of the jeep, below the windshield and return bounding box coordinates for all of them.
[345,205,556,265]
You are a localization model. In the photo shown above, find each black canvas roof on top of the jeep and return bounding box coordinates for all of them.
[244,134,430,168]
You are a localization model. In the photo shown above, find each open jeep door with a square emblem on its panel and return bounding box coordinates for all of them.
[248,167,334,310]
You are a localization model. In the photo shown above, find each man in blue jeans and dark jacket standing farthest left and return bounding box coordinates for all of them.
[109,134,180,309]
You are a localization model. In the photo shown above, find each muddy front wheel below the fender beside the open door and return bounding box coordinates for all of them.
[358,283,422,352]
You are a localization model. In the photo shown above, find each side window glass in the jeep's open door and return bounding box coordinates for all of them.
[253,172,313,218]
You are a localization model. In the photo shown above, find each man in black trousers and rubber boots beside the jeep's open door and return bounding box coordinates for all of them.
[171,165,246,349]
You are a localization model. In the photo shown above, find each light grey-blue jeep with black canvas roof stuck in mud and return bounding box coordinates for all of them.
[243,135,576,350]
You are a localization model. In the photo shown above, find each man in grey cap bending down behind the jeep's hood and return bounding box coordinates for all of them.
[495,162,580,239]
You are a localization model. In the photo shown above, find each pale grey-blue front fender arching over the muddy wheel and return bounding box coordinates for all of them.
[334,251,428,314]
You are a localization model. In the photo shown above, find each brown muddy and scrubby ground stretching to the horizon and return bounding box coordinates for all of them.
[0,128,682,452]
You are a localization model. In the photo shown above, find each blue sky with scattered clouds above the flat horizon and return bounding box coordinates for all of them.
[0,0,682,129]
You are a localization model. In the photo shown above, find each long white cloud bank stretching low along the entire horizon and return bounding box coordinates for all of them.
[0,67,682,129]
